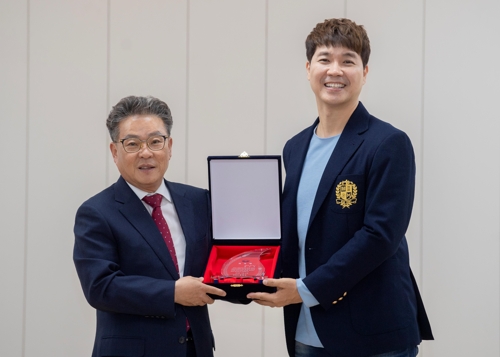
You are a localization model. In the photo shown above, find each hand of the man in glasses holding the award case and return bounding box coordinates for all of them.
[174,276,226,306]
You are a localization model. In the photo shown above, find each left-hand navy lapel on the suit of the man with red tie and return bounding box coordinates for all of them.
[115,177,179,279]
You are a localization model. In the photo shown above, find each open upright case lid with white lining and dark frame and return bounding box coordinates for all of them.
[208,155,281,245]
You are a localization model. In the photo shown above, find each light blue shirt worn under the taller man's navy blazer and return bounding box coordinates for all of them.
[295,129,340,347]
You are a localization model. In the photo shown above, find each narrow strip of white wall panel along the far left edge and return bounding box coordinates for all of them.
[0,0,28,356]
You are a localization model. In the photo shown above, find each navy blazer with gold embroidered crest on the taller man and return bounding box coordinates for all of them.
[282,103,432,357]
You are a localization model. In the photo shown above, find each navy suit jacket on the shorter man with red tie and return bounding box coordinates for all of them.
[73,177,214,357]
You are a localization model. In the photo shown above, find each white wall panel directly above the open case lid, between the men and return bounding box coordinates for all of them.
[187,0,266,187]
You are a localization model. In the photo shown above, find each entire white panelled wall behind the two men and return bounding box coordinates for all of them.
[0,0,500,357]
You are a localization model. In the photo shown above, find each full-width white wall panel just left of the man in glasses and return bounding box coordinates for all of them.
[25,0,107,357]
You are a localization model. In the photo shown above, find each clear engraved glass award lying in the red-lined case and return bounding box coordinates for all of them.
[221,248,271,280]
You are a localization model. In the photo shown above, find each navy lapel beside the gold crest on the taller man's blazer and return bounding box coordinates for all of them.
[309,102,370,227]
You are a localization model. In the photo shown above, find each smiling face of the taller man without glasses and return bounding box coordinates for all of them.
[306,46,368,112]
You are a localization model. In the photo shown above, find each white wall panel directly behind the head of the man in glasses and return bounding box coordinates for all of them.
[108,0,187,184]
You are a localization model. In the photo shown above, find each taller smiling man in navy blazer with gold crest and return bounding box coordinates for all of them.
[248,19,433,357]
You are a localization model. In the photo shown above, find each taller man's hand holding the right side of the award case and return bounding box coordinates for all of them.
[247,278,302,307]
